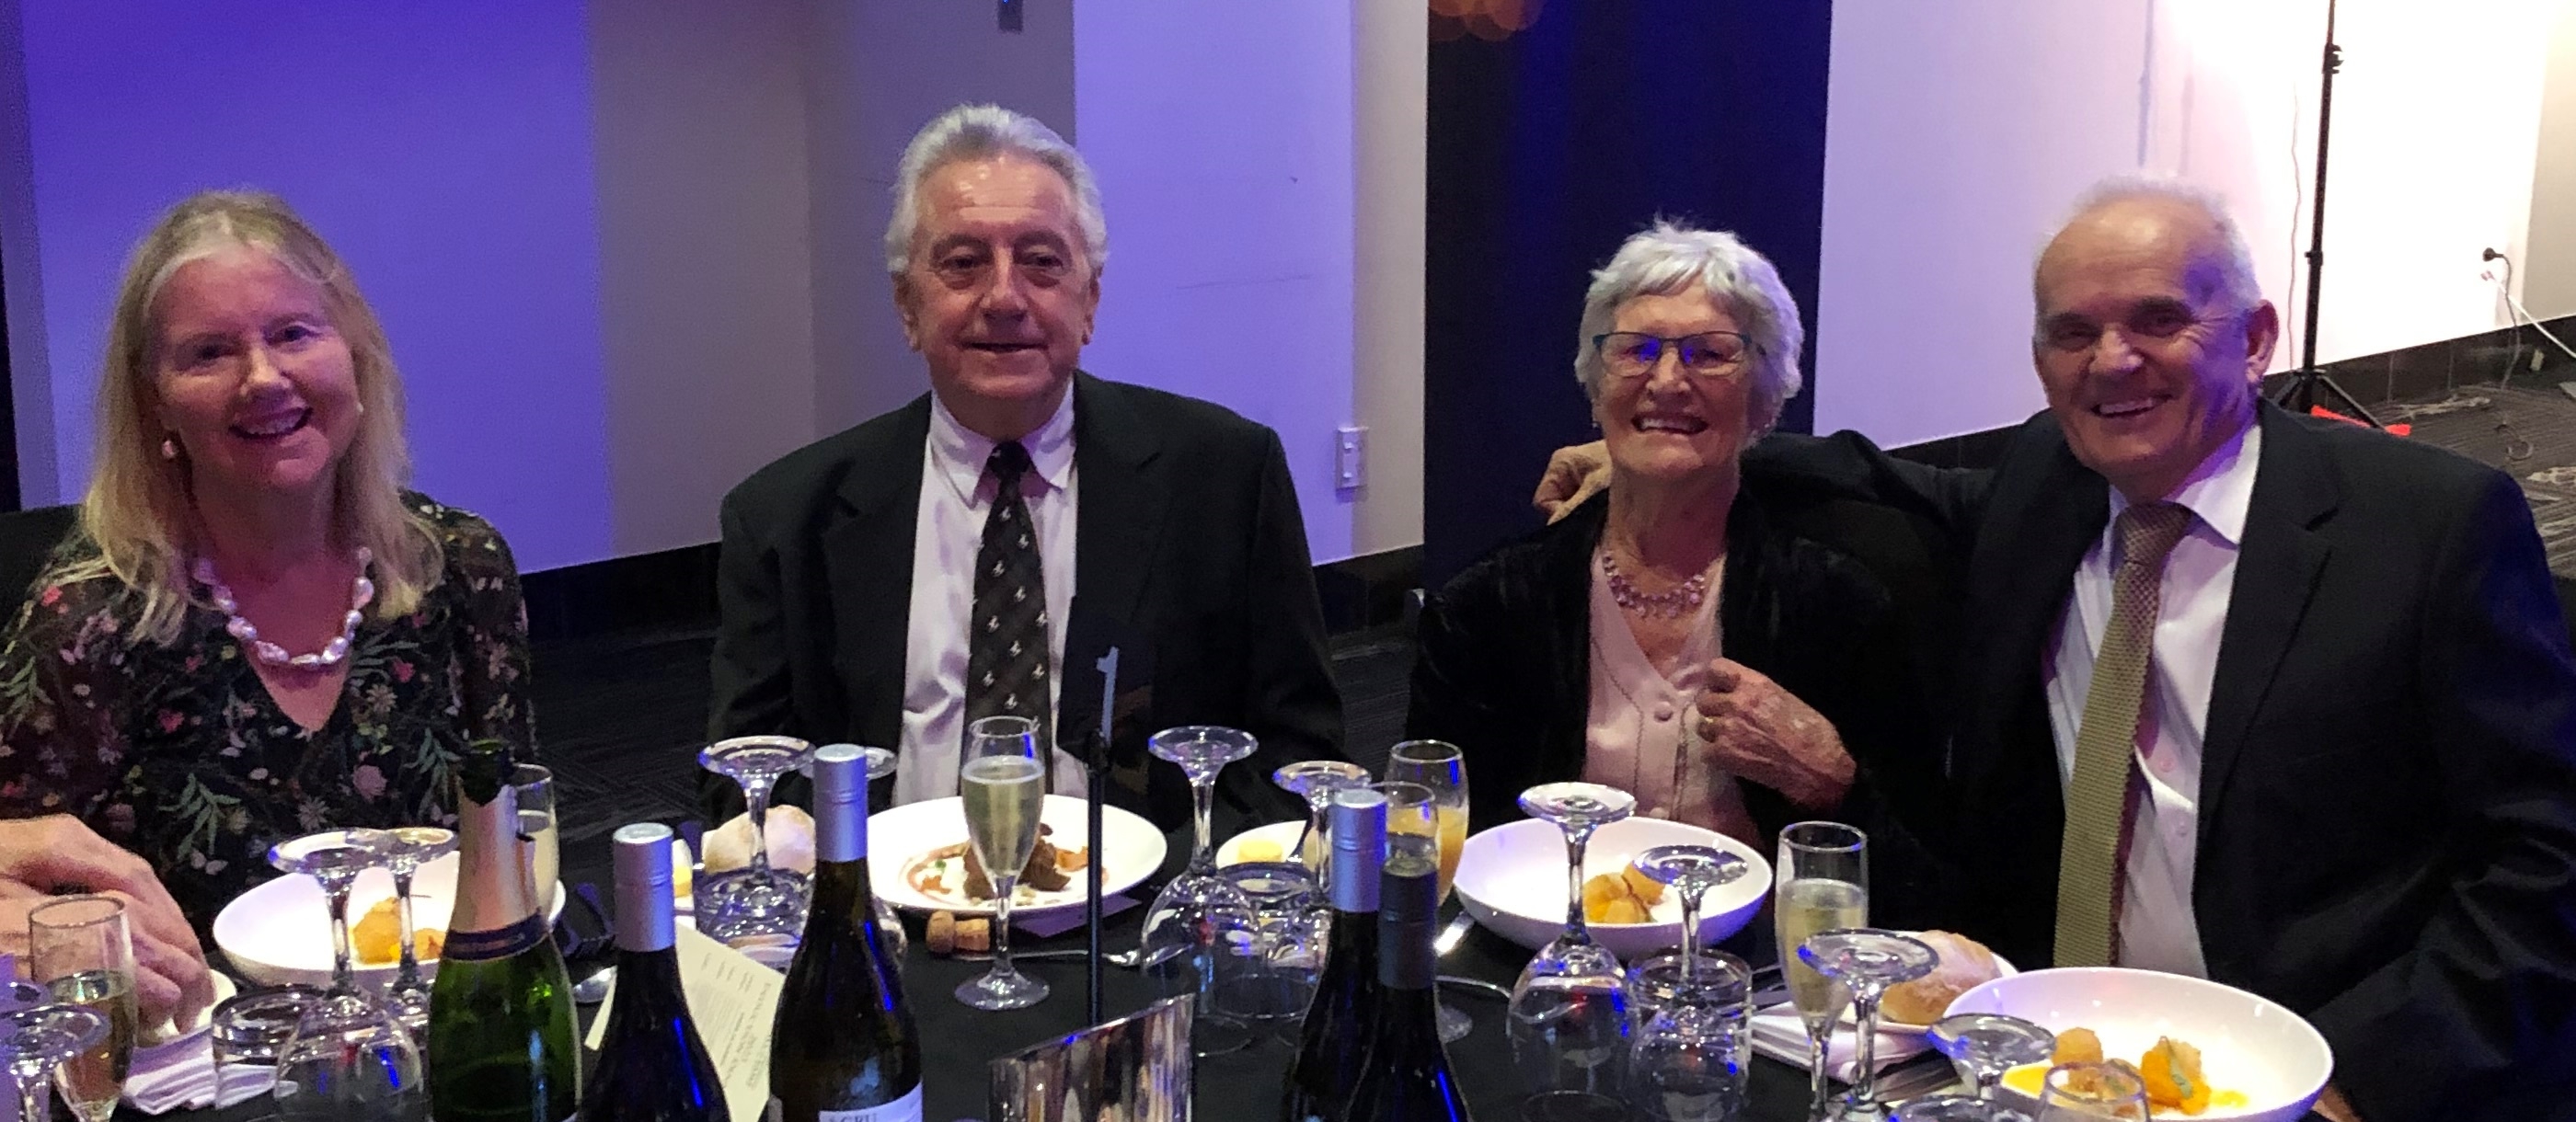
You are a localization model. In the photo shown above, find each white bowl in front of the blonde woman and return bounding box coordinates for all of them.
[213,852,564,986]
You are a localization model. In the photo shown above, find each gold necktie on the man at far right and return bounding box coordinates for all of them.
[2055,502,2192,965]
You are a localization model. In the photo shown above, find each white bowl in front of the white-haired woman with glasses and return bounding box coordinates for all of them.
[1458,819,1770,963]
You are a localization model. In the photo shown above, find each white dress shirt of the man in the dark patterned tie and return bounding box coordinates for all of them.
[894,389,1085,803]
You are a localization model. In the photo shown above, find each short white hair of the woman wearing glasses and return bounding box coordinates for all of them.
[1574,219,1806,438]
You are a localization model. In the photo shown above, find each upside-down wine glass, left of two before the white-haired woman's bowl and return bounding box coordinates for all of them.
[1512,783,1636,1122]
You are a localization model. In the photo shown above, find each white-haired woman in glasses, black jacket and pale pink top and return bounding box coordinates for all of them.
[1407,222,1942,910]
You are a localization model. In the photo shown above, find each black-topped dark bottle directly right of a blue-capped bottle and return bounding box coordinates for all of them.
[1347,849,1468,1122]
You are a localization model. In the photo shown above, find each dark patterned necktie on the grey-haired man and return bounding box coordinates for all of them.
[966,440,1053,744]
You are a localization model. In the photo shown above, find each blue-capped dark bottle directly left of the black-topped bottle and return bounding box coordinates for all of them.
[1281,787,1386,1122]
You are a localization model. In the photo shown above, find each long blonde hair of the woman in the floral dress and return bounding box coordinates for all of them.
[67,190,445,644]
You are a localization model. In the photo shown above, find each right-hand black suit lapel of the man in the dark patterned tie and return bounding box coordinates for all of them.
[1075,373,1167,689]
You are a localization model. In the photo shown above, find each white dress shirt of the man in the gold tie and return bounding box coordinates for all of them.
[2048,425,2261,978]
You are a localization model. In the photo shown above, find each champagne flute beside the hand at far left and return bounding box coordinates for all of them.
[26,896,134,1122]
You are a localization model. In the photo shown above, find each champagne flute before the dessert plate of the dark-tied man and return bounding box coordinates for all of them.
[959,718,1046,1009]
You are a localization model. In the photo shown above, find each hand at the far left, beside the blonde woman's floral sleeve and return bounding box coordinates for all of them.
[0,813,213,1026]
